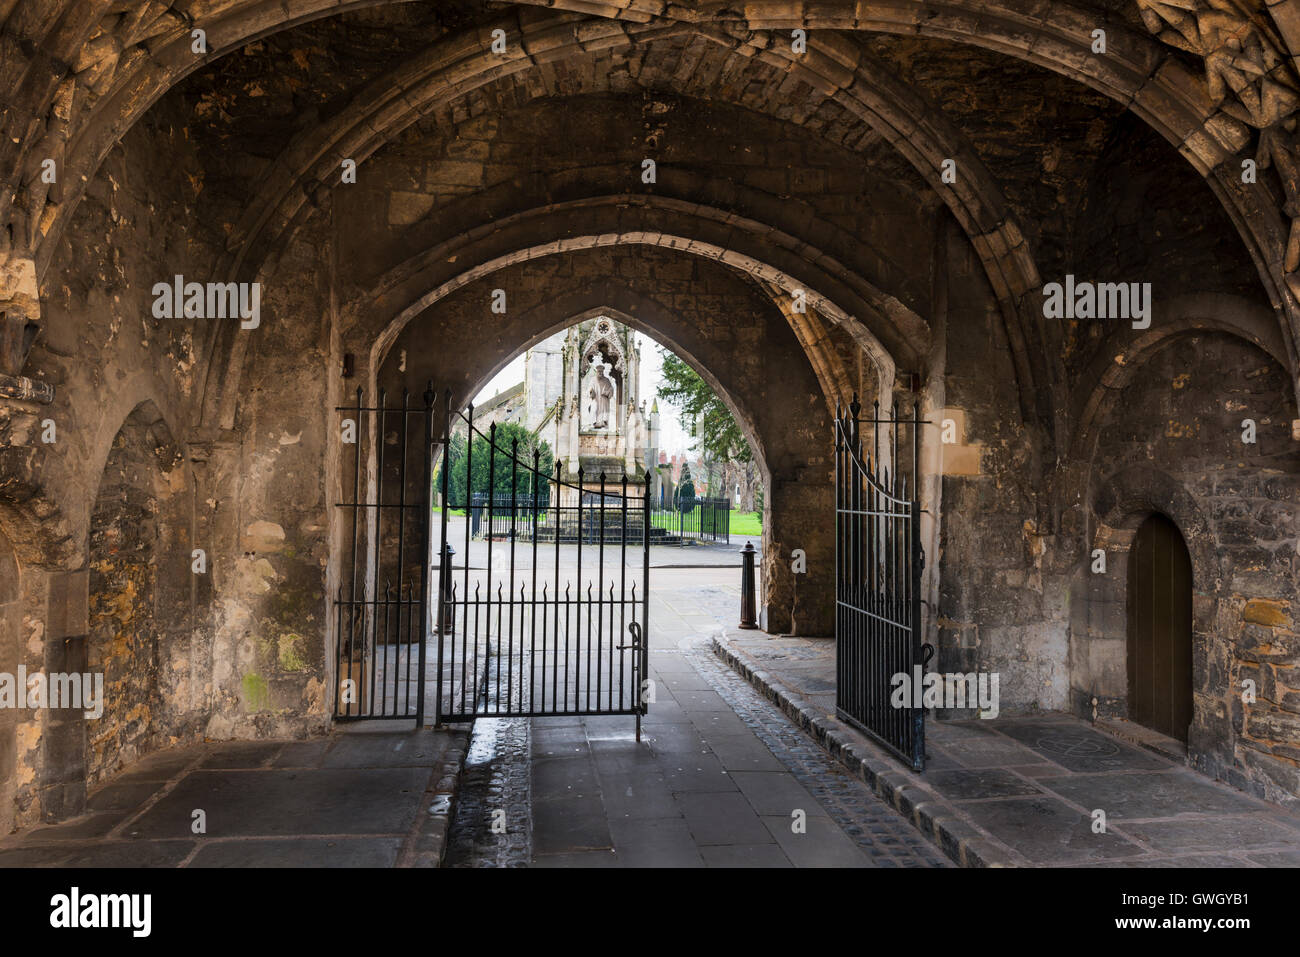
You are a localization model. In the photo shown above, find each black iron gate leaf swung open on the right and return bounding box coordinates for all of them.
[835,395,933,771]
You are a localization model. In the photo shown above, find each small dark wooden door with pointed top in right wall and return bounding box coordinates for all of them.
[1128,515,1192,741]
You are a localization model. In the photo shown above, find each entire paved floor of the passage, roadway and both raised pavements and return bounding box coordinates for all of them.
[0,550,1300,867]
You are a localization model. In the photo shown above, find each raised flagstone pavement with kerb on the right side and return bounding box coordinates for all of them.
[712,633,1300,867]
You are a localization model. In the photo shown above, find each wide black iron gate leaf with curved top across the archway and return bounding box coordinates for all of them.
[436,395,650,739]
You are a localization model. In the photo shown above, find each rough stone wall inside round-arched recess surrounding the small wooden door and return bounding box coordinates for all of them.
[1071,333,1300,801]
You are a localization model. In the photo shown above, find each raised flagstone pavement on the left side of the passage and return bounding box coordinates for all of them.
[0,722,468,867]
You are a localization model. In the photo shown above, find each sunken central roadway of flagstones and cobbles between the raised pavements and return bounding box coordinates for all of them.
[447,567,949,867]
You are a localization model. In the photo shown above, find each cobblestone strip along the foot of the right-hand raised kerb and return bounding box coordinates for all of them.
[686,640,953,867]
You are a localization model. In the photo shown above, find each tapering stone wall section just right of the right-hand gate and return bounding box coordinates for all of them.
[927,218,1066,713]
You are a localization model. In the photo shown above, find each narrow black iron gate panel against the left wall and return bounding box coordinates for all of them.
[334,385,434,724]
